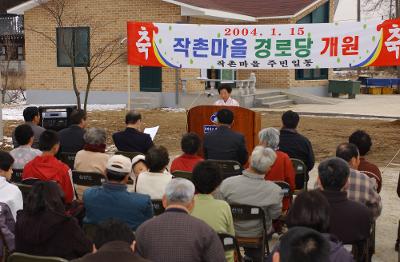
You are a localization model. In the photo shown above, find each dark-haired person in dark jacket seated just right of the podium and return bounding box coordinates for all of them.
[279,110,315,189]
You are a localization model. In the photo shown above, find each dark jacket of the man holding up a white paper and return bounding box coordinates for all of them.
[113,128,153,154]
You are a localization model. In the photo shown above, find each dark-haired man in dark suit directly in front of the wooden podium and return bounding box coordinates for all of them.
[203,109,248,165]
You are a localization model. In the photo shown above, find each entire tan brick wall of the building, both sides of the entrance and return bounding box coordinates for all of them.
[25,0,333,97]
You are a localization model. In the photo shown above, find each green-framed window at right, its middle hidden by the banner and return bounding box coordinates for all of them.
[295,1,329,80]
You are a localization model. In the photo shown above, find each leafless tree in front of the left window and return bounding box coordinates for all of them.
[27,0,126,111]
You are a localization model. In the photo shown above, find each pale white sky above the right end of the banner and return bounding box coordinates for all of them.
[334,0,394,22]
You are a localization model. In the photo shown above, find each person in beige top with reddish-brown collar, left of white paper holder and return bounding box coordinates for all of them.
[74,127,110,175]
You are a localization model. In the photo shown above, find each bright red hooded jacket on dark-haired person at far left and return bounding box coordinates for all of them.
[22,155,74,203]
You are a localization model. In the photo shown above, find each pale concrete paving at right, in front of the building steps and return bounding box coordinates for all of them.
[253,95,400,119]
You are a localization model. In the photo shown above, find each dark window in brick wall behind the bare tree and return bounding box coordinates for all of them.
[57,27,90,67]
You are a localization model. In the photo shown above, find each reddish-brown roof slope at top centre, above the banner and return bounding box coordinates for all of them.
[166,0,320,18]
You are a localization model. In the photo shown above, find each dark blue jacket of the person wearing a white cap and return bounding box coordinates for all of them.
[83,183,153,231]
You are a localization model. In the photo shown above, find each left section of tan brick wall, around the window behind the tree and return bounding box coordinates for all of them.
[25,0,199,91]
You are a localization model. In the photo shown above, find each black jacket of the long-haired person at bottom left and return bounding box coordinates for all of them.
[15,210,92,260]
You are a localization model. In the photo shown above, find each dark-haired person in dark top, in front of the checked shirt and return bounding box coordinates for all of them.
[318,157,373,244]
